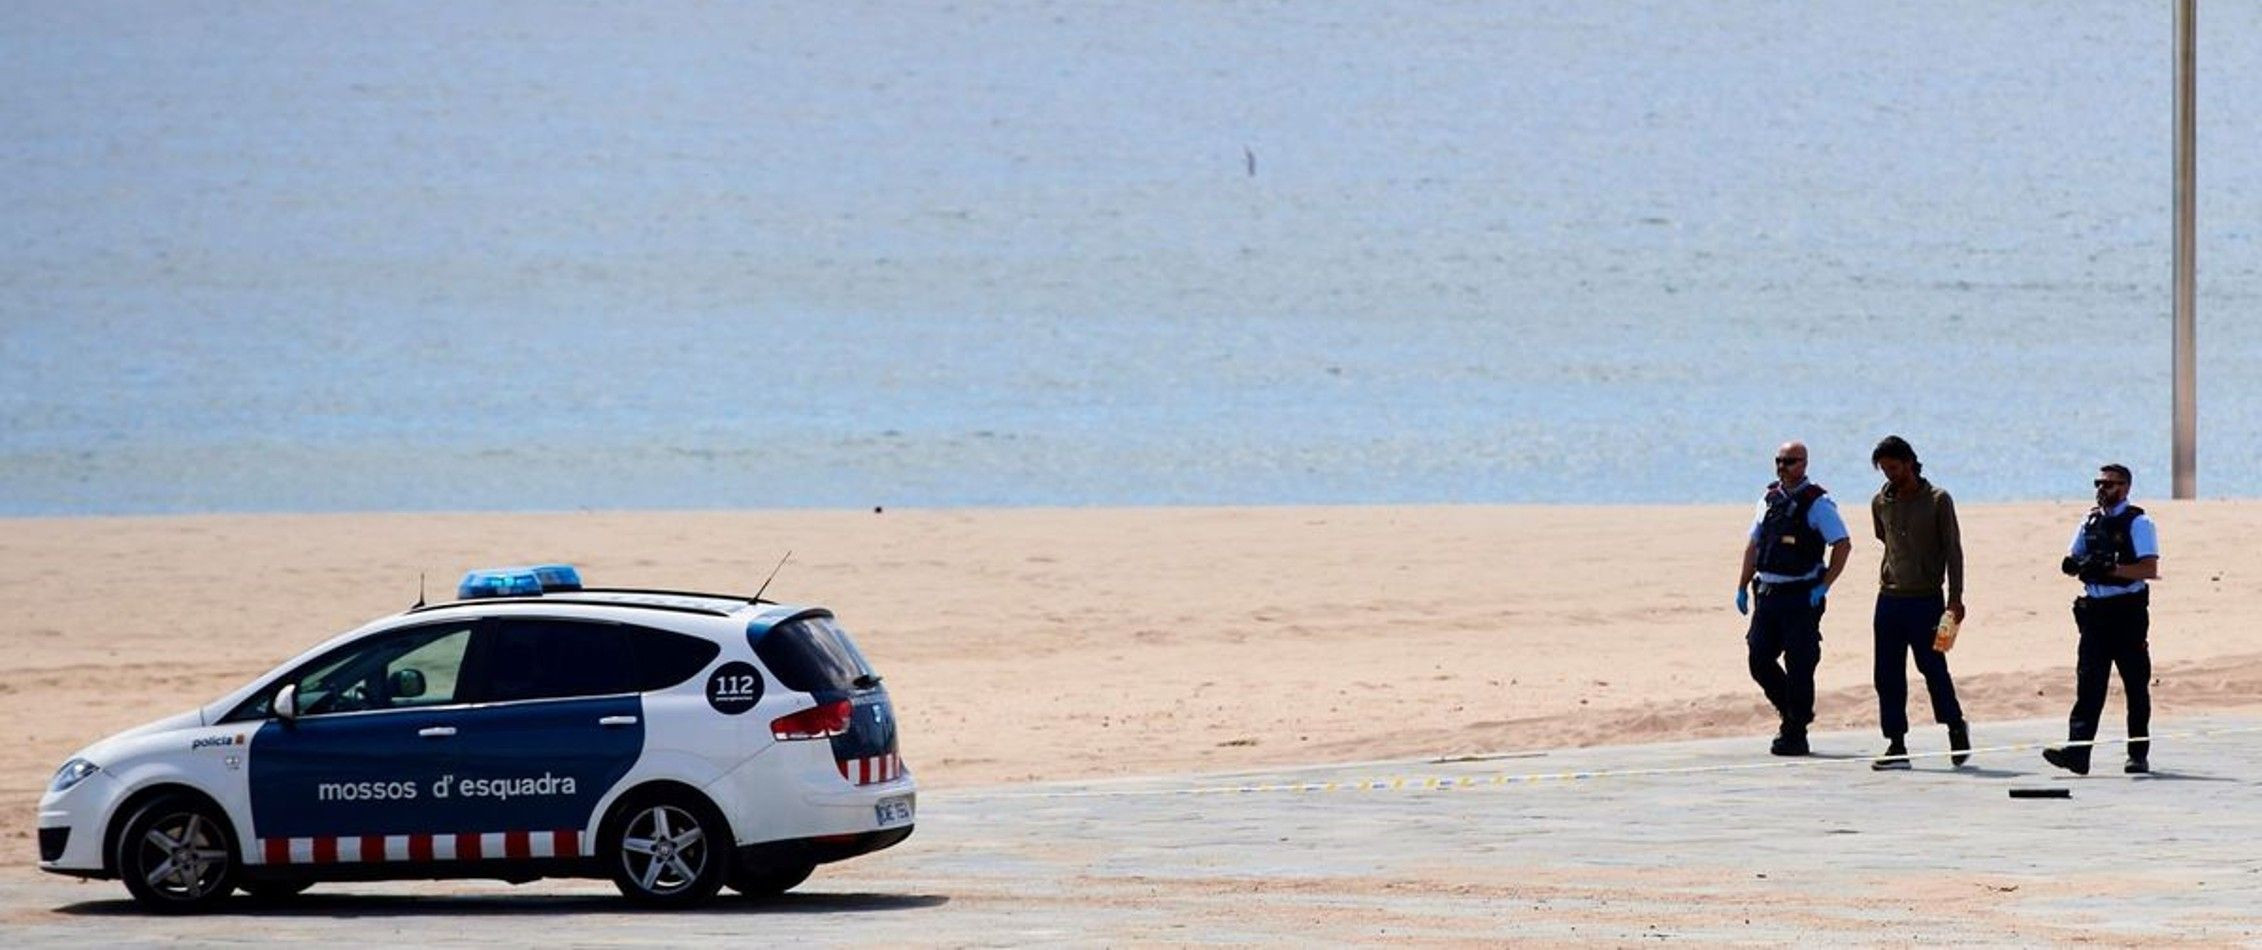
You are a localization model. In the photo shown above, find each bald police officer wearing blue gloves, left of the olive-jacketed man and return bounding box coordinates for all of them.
[1735,441,1853,755]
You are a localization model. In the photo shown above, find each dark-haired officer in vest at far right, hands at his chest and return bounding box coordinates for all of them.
[2043,464,2160,776]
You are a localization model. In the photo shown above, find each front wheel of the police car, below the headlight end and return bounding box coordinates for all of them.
[113,794,240,914]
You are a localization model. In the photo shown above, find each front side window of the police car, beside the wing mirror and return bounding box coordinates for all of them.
[226,622,473,722]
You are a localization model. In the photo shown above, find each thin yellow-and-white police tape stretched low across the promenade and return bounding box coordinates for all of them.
[984,726,2262,798]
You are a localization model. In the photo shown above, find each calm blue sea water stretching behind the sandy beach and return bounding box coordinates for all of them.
[0,0,2262,516]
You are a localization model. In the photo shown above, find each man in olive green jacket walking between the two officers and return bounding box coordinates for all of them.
[1868,437,1972,769]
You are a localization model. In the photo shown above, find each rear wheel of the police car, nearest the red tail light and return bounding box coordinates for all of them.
[604,794,733,907]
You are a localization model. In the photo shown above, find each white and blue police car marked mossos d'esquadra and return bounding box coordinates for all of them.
[38,565,916,912]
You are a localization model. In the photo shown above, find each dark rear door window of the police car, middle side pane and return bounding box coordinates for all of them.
[477,618,636,703]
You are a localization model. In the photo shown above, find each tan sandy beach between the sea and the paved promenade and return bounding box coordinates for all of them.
[0,500,2262,855]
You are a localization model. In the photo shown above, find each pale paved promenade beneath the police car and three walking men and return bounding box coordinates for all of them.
[0,717,2262,945]
